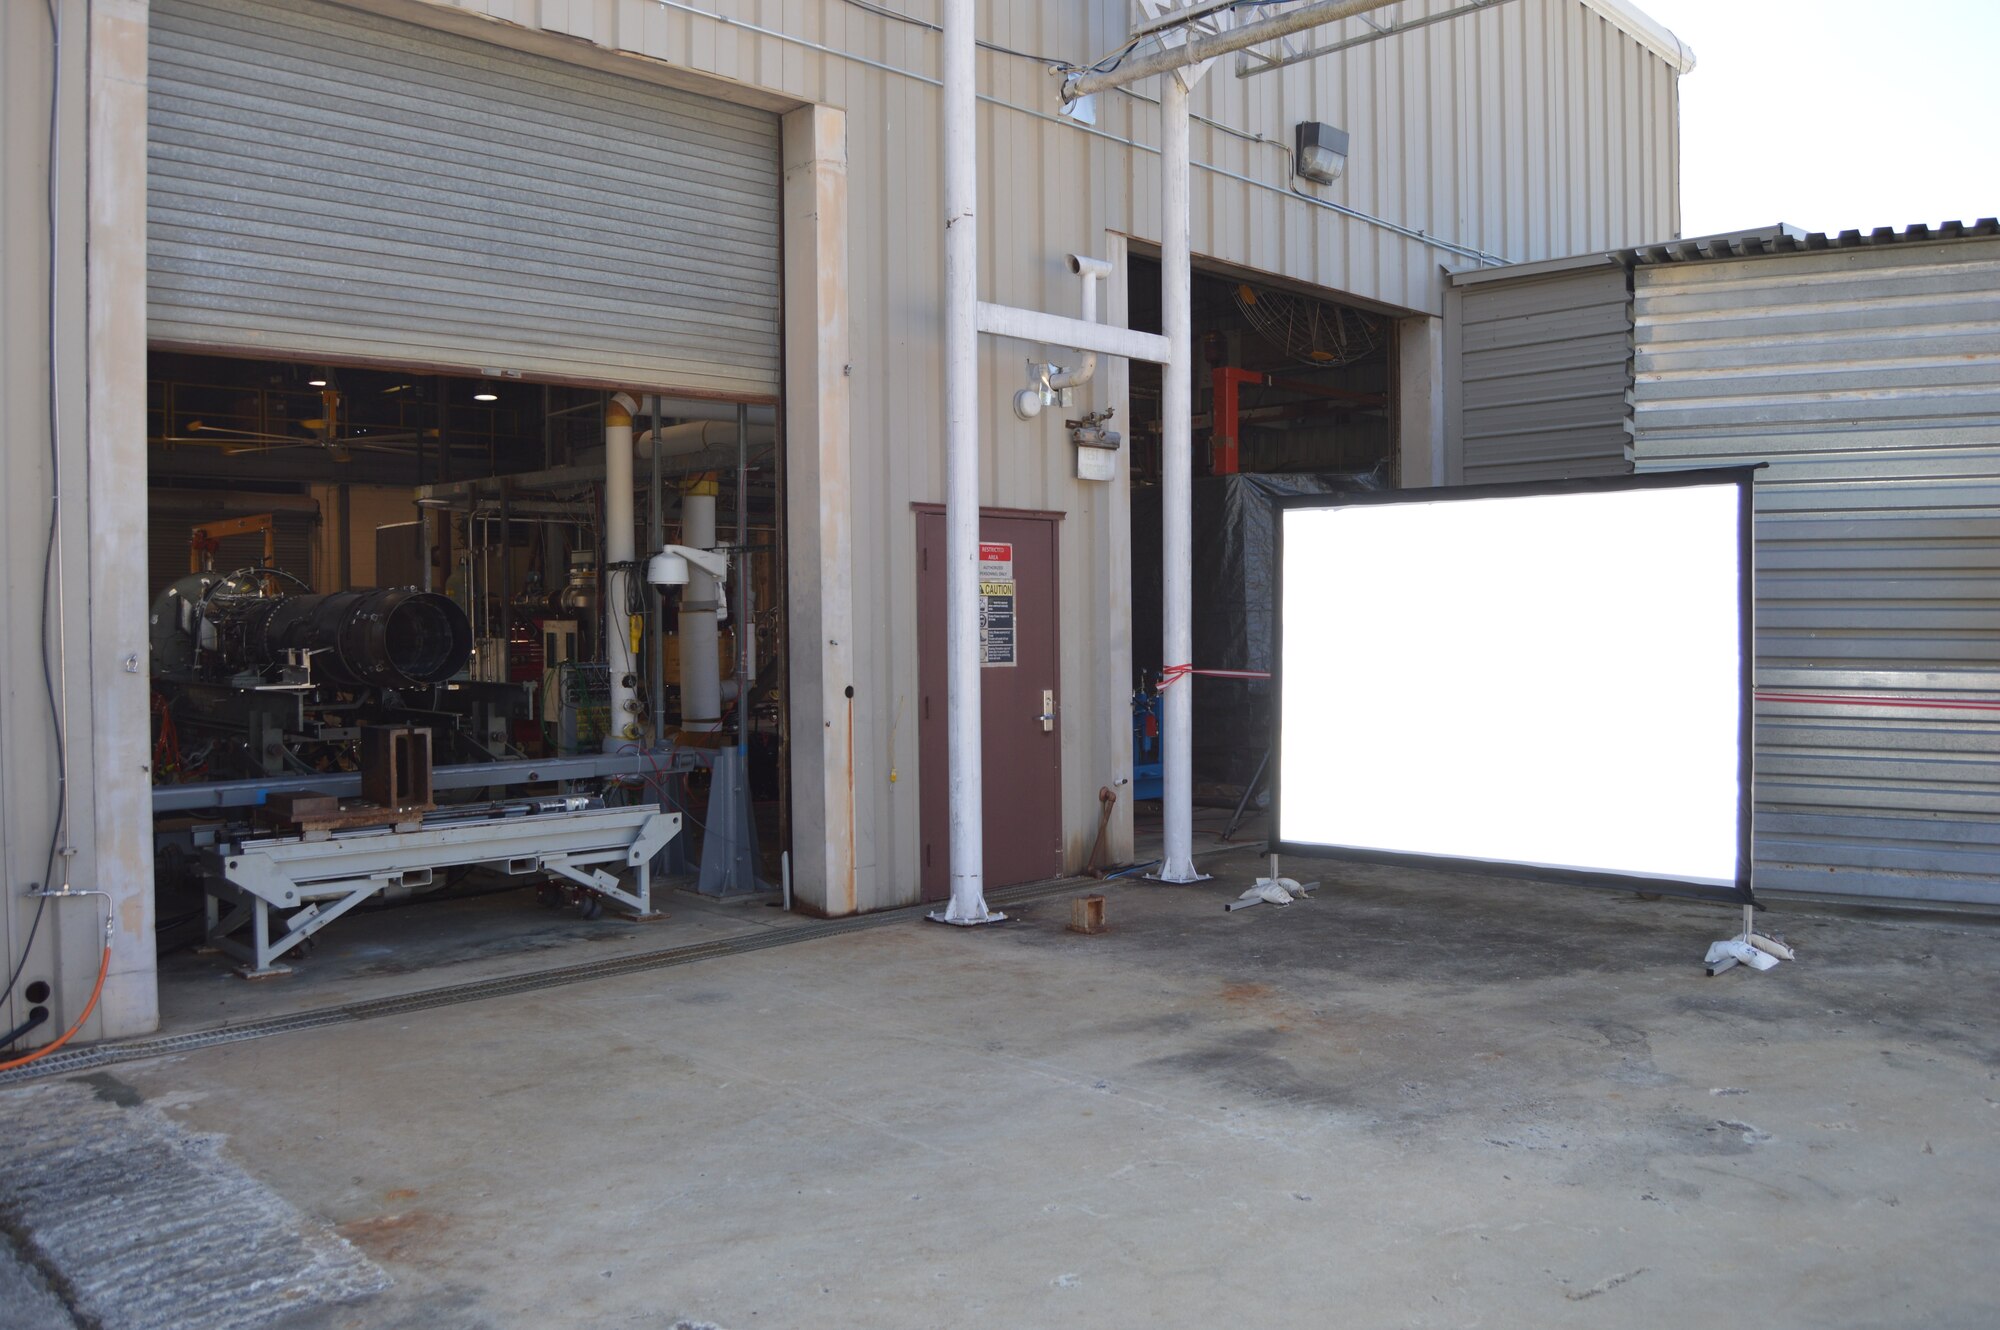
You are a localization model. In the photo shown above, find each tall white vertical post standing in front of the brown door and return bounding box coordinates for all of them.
[942,0,986,922]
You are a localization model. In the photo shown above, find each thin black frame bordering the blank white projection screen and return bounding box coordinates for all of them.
[1268,466,1762,906]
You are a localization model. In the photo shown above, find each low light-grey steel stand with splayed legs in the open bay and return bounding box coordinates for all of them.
[200,808,680,978]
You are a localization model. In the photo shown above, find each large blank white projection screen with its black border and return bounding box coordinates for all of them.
[1272,468,1752,902]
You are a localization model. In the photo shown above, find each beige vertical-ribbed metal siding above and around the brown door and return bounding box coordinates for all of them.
[378,0,1680,908]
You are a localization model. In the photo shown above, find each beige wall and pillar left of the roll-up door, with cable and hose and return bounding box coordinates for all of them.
[0,0,156,1042]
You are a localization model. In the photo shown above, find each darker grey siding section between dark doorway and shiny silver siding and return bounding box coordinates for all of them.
[1446,264,1632,484]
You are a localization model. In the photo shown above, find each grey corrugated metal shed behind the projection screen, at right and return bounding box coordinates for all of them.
[1444,218,2000,906]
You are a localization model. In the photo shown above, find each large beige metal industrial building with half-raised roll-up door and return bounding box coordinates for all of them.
[0,0,1692,1044]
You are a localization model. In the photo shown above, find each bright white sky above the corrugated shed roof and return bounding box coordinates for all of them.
[1638,0,2000,236]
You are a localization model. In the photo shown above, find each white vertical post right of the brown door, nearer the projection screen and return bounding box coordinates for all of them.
[1158,72,1198,882]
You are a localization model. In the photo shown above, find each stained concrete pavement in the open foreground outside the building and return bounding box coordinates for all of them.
[0,856,2000,1330]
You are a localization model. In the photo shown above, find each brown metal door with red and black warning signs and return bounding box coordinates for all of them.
[916,508,1062,900]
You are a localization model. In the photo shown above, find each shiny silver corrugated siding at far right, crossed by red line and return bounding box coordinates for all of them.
[1634,240,2000,904]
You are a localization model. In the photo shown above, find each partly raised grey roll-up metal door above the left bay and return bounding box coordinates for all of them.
[148,0,780,396]
